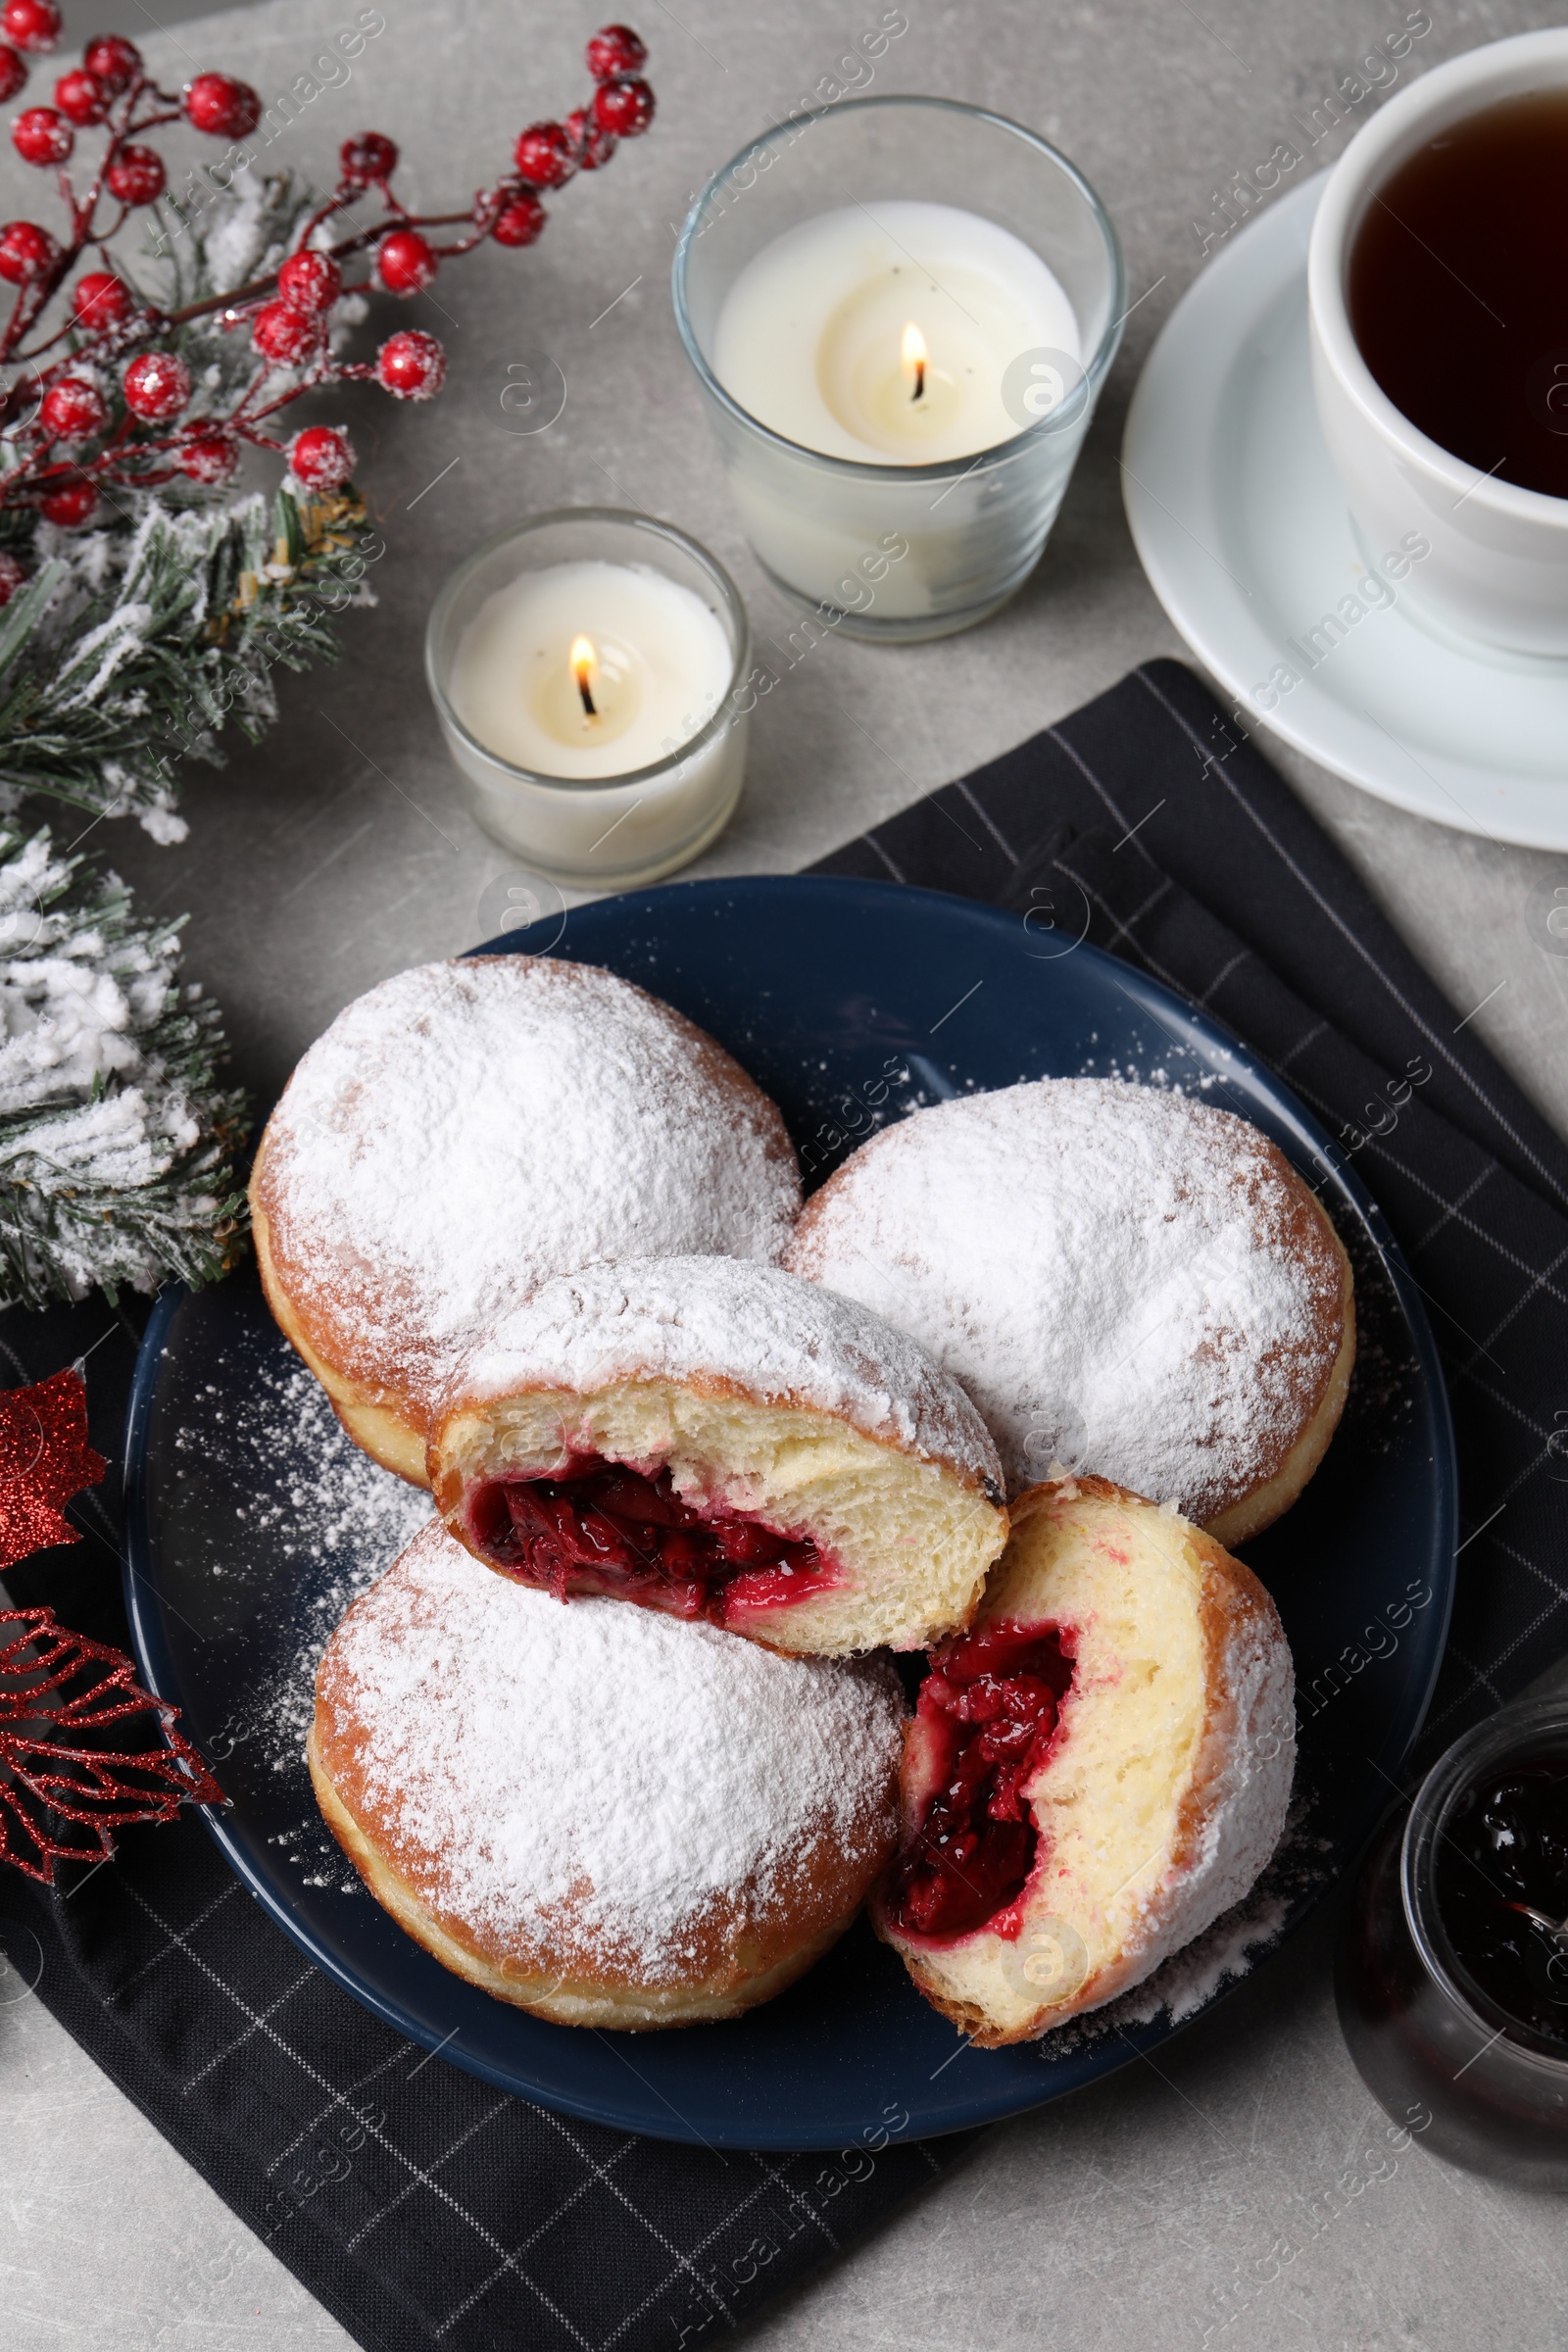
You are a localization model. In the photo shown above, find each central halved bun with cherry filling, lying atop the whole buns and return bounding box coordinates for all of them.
[430,1258,1008,1656]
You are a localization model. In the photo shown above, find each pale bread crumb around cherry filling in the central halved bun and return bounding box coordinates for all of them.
[430,1381,1006,1658]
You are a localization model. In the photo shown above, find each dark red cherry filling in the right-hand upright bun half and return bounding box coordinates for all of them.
[889,1623,1074,1936]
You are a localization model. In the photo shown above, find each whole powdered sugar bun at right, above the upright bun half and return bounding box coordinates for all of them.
[785,1077,1356,1543]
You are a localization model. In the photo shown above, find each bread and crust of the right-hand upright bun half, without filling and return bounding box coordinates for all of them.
[879,1480,1296,2046]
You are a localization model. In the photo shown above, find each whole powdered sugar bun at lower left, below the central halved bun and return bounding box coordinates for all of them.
[311,1522,906,2030]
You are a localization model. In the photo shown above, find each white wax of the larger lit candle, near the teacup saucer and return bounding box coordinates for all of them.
[712,197,1091,635]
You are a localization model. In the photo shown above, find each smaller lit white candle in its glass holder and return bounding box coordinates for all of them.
[425,506,750,892]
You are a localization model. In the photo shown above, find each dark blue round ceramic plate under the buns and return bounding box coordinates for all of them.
[127,877,1455,2147]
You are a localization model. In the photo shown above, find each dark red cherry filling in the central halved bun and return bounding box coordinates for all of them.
[467,1453,839,1625]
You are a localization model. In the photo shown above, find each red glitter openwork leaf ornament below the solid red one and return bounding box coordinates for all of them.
[0,1608,223,1886]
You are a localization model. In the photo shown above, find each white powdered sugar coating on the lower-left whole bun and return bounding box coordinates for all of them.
[322,1524,903,1978]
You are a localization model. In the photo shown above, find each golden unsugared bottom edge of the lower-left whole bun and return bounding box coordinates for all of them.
[306,1724,860,2033]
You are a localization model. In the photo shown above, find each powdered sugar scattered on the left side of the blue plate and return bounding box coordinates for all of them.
[174,1354,430,1774]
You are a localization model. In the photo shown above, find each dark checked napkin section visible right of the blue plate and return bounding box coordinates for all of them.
[815,661,1568,1757]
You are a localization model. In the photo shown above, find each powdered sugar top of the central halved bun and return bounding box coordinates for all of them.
[454,1258,1002,1495]
